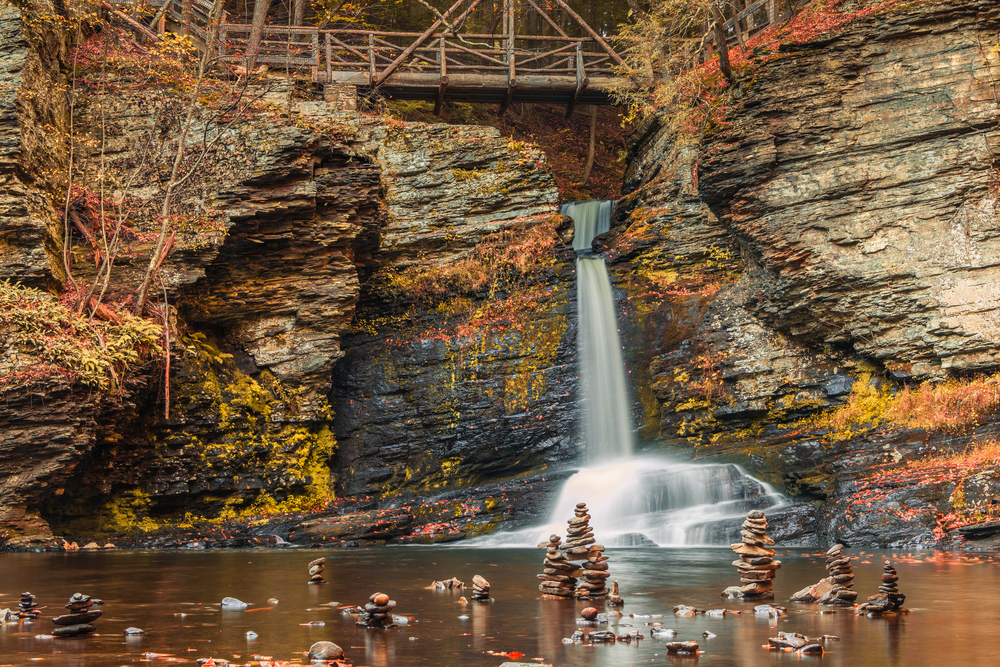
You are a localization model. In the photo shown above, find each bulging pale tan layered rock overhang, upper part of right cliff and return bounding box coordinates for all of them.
[699,1,1000,375]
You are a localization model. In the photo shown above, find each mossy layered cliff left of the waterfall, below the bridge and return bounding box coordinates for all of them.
[0,5,575,546]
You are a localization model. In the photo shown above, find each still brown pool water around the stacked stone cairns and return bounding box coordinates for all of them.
[0,547,1000,667]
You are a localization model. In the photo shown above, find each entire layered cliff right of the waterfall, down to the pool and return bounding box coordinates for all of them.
[601,1,1000,546]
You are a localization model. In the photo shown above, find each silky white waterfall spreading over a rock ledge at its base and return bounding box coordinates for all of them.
[469,201,787,546]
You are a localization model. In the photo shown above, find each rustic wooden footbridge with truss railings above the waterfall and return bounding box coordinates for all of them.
[117,0,778,115]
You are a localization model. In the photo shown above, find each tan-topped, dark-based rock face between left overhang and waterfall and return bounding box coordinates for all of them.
[331,121,578,495]
